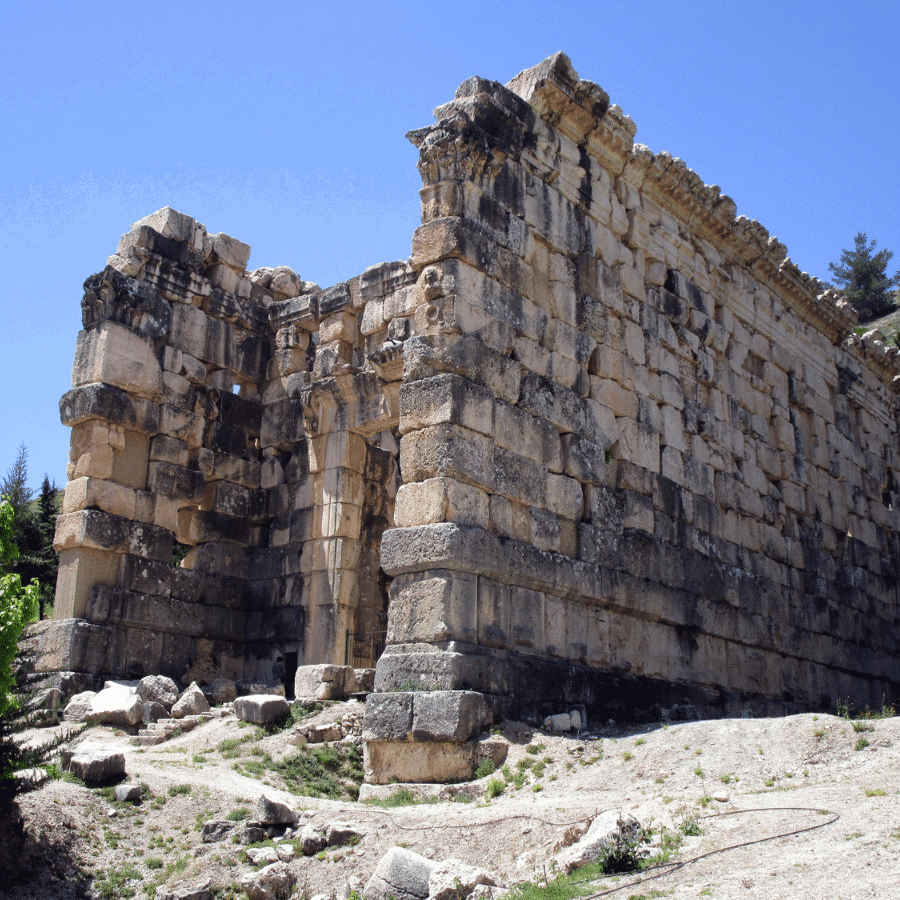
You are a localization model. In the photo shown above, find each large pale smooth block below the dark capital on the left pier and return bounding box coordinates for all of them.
[72,321,162,400]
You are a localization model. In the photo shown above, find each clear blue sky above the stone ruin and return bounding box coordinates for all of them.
[0,0,900,488]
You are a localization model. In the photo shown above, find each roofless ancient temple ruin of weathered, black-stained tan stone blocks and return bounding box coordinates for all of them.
[29,54,900,780]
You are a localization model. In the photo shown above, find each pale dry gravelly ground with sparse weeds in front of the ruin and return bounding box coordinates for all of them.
[0,701,900,900]
